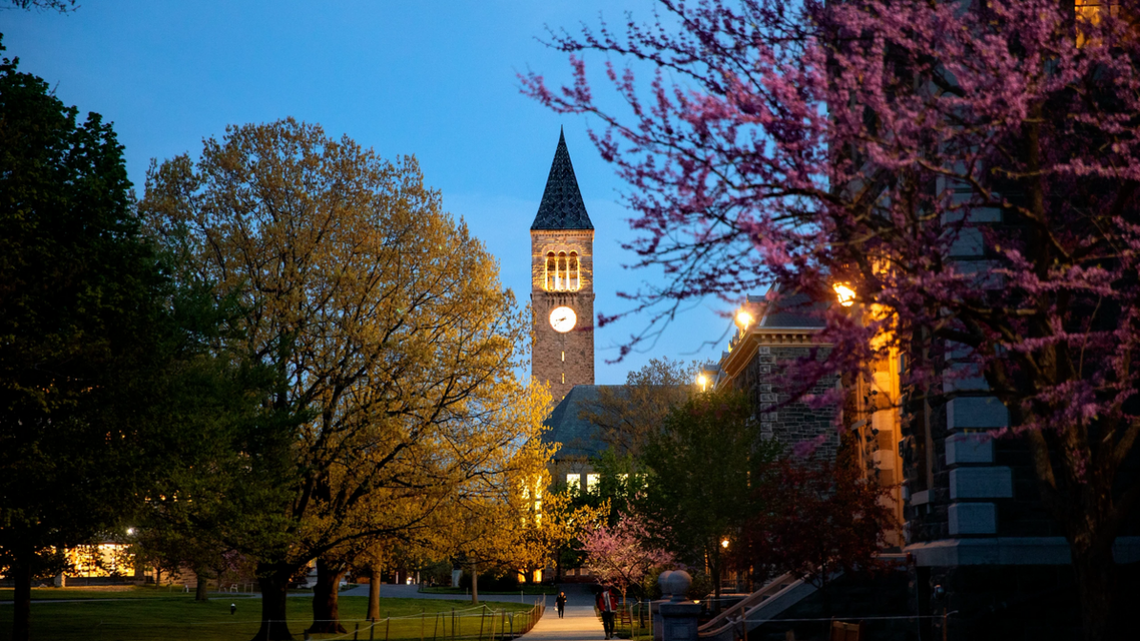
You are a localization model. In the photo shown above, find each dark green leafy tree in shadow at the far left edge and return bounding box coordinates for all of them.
[0,38,253,640]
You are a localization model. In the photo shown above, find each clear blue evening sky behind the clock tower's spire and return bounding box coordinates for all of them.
[0,0,728,383]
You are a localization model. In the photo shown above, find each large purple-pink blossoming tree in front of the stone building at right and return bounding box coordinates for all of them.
[524,0,1140,639]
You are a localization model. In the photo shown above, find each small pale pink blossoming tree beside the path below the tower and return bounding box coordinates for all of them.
[581,514,674,601]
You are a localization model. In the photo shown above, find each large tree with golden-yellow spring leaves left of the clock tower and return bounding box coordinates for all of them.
[141,120,542,639]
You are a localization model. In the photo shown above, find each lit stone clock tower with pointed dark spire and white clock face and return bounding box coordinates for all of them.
[530,128,594,403]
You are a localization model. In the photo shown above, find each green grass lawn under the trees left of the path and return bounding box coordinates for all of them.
[0,589,531,641]
